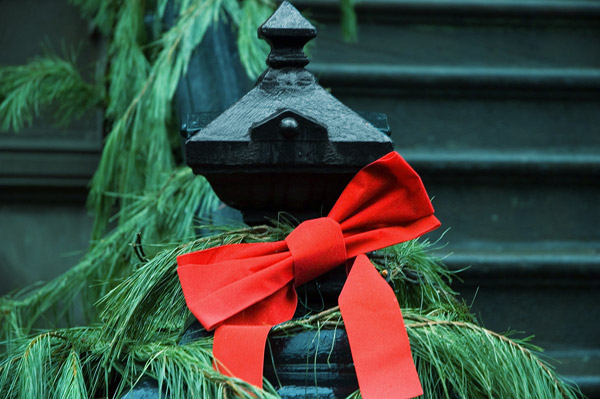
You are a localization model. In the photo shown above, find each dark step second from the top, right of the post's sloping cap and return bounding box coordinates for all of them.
[314,69,600,158]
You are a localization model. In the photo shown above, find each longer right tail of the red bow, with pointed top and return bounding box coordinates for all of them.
[339,255,423,399]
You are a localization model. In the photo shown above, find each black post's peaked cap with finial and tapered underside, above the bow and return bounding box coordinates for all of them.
[186,2,392,224]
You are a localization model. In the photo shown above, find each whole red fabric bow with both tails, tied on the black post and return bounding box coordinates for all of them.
[177,152,440,399]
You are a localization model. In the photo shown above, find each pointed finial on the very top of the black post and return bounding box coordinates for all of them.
[258,1,317,68]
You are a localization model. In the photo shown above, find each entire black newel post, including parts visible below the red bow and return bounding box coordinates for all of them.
[184,1,393,398]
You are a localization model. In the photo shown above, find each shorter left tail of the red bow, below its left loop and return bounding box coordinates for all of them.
[213,325,272,388]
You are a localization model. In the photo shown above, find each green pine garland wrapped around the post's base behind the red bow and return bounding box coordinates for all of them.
[0,225,579,399]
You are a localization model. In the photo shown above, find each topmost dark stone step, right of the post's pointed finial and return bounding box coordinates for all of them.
[302,0,600,68]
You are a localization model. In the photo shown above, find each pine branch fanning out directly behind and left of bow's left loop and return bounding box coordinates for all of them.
[99,226,290,358]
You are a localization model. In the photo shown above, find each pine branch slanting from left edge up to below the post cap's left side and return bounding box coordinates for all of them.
[0,168,218,340]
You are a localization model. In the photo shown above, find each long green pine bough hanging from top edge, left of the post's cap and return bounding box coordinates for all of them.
[88,0,230,238]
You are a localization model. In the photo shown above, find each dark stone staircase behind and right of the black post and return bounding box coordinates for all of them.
[294,0,600,398]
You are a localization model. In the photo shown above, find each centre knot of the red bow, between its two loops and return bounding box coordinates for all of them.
[285,217,347,287]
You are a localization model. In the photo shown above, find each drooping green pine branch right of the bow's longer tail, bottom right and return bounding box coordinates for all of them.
[405,315,580,399]
